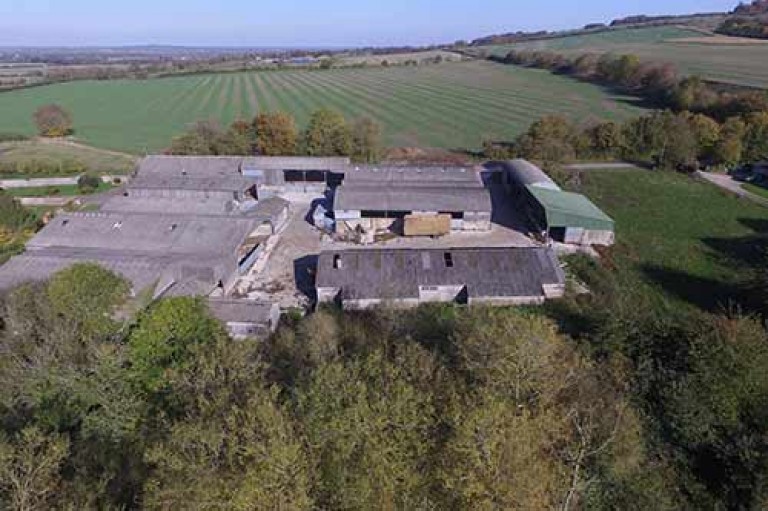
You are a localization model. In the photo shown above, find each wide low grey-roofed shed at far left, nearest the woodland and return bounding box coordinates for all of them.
[0,207,282,296]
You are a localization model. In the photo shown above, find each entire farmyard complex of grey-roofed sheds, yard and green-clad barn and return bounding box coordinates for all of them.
[0,156,614,337]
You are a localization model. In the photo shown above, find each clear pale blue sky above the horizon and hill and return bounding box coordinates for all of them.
[0,0,737,46]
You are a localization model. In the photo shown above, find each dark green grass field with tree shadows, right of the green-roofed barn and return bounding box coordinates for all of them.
[568,170,768,310]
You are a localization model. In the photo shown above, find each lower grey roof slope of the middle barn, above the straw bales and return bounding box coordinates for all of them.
[334,184,491,212]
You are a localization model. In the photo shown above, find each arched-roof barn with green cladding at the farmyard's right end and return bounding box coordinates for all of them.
[502,160,614,245]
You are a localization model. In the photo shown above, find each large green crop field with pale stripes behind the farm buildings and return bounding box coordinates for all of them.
[0,61,641,154]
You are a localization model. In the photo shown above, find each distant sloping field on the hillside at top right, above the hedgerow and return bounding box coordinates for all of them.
[476,27,768,88]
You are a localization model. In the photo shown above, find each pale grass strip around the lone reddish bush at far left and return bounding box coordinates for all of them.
[0,140,136,178]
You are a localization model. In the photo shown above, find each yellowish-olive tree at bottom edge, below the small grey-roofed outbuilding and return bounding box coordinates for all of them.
[144,338,314,510]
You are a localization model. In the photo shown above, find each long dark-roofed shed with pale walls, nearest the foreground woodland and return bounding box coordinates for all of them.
[316,247,565,309]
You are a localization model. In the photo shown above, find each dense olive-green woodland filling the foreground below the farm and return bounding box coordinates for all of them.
[0,235,768,509]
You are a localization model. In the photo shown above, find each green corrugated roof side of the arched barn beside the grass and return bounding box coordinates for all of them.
[526,185,613,231]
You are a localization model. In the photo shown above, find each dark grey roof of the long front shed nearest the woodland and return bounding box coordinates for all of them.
[316,247,565,299]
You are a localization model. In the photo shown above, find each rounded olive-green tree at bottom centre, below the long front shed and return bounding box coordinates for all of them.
[298,350,435,509]
